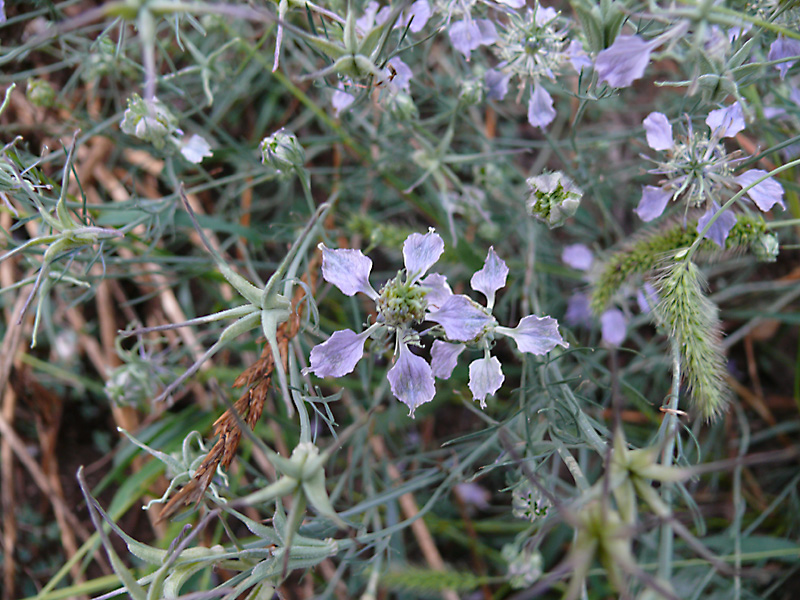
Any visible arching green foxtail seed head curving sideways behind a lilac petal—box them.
[591,214,774,315]
